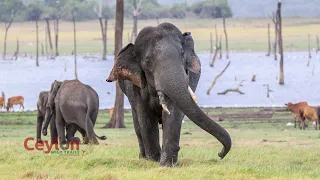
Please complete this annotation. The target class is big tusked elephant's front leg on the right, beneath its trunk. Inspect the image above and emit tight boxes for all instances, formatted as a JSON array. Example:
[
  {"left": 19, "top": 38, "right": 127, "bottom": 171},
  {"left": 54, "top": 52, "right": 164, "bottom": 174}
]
[{"left": 159, "top": 93, "right": 184, "bottom": 167}]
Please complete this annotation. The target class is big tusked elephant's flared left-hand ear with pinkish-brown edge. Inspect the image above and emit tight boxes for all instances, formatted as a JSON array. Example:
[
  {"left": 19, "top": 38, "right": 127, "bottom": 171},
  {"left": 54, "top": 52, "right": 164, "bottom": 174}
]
[{"left": 107, "top": 43, "right": 146, "bottom": 88}]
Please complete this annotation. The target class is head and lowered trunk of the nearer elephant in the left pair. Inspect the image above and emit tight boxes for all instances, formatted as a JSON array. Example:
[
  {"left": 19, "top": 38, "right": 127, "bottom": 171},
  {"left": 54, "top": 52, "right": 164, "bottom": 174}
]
[{"left": 42, "top": 80, "right": 62, "bottom": 136}]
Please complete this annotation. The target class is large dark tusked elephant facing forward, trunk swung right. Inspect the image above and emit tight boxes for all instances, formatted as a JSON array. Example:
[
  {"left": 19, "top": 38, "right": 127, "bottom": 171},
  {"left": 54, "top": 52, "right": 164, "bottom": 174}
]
[{"left": 107, "top": 23, "right": 231, "bottom": 166}]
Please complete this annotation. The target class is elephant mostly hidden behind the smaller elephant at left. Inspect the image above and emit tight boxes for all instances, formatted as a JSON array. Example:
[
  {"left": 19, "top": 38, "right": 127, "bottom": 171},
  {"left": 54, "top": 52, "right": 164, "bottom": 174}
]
[{"left": 37, "top": 91, "right": 85, "bottom": 144}]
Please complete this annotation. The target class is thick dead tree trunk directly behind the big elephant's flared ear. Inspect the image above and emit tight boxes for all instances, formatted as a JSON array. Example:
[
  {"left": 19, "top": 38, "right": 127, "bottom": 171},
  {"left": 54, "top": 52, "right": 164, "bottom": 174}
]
[{"left": 105, "top": 0, "right": 125, "bottom": 128}]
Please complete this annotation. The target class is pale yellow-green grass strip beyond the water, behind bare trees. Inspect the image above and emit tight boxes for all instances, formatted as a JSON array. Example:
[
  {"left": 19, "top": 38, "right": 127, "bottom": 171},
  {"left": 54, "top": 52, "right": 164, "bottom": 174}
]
[{"left": 0, "top": 18, "right": 320, "bottom": 56}]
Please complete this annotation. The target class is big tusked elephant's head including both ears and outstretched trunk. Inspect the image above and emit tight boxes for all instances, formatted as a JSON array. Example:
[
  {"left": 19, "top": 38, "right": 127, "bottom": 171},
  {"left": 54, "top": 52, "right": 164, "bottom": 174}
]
[{"left": 107, "top": 23, "right": 231, "bottom": 158}]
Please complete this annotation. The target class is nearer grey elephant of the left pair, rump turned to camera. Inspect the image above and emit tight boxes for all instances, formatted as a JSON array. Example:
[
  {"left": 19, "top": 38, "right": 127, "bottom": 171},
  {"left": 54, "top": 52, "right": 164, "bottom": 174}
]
[{"left": 42, "top": 80, "right": 106, "bottom": 144}]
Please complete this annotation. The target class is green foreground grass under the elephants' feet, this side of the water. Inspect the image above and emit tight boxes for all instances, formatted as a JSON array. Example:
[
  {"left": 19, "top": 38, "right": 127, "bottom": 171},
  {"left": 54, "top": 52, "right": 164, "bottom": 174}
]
[{"left": 0, "top": 108, "right": 320, "bottom": 180}]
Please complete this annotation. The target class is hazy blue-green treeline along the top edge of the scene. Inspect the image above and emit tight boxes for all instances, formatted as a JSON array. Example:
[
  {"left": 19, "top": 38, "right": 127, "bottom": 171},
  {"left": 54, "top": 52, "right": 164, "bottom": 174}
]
[{"left": 0, "top": 0, "right": 232, "bottom": 22}]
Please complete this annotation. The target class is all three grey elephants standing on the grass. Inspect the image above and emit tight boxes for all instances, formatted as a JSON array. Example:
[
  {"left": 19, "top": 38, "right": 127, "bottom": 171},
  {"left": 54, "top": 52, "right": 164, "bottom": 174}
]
[{"left": 37, "top": 23, "right": 232, "bottom": 166}]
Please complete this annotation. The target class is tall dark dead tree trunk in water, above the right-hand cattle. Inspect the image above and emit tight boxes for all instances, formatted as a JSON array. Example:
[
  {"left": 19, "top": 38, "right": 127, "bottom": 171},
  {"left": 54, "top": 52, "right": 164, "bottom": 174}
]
[{"left": 277, "top": 1, "right": 284, "bottom": 85}]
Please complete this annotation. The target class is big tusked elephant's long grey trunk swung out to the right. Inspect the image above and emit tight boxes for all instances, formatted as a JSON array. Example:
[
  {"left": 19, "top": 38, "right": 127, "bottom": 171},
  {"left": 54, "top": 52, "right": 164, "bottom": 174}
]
[{"left": 155, "top": 65, "right": 232, "bottom": 159}]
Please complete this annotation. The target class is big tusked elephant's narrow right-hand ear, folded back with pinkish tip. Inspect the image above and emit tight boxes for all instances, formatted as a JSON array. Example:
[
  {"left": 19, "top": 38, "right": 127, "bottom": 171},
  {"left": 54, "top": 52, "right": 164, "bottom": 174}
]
[{"left": 182, "top": 32, "right": 201, "bottom": 74}]
